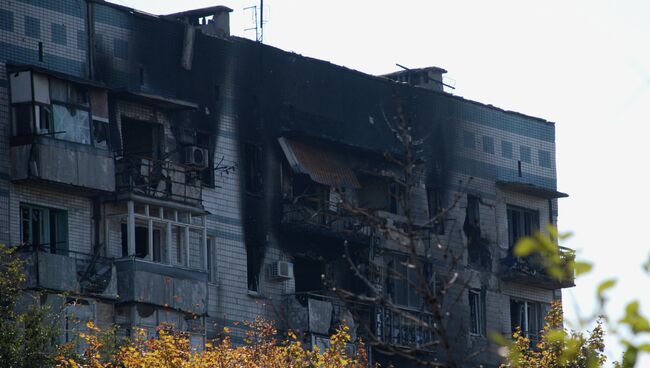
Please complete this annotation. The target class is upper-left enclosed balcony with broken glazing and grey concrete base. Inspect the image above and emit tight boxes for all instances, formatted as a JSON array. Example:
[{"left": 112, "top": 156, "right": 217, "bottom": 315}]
[{"left": 10, "top": 67, "right": 115, "bottom": 192}]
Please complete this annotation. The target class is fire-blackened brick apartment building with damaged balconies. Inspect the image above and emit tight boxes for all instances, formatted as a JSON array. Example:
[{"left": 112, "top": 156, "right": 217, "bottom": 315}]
[{"left": 0, "top": 0, "right": 573, "bottom": 367}]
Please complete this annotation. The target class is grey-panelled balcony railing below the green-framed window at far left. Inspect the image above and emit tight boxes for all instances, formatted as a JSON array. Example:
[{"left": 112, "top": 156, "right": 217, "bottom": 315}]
[{"left": 20, "top": 244, "right": 117, "bottom": 298}]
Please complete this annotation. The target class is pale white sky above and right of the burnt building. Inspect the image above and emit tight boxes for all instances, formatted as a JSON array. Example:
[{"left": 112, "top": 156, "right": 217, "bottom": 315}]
[{"left": 112, "top": 0, "right": 650, "bottom": 367}]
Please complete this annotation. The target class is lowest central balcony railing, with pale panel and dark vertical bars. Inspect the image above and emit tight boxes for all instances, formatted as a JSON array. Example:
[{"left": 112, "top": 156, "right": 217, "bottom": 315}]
[{"left": 286, "top": 292, "right": 434, "bottom": 351}]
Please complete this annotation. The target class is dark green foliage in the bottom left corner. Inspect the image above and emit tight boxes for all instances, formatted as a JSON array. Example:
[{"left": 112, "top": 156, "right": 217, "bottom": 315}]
[{"left": 0, "top": 245, "right": 58, "bottom": 368}]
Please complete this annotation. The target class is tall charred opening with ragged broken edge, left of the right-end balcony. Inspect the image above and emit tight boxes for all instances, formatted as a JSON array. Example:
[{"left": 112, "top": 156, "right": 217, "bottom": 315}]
[{"left": 463, "top": 194, "right": 492, "bottom": 270}]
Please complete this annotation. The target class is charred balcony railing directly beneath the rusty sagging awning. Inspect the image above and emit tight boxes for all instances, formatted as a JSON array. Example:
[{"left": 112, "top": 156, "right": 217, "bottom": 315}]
[{"left": 282, "top": 197, "right": 374, "bottom": 243}]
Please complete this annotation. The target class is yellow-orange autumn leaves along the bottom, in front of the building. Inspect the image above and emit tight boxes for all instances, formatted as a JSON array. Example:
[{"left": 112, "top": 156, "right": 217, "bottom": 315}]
[{"left": 57, "top": 319, "right": 367, "bottom": 368}]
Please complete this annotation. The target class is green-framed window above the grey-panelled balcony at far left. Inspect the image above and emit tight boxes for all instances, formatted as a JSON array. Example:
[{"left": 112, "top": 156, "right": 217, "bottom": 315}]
[{"left": 20, "top": 204, "right": 68, "bottom": 255}]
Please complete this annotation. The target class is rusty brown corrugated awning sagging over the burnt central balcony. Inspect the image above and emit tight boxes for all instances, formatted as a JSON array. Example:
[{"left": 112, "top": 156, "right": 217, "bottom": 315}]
[{"left": 278, "top": 137, "right": 361, "bottom": 188}]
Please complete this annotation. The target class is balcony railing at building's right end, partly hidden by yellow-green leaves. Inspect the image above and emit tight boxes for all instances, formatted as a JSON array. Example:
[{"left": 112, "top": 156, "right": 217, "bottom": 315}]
[{"left": 499, "top": 247, "right": 575, "bottom": 289}]
